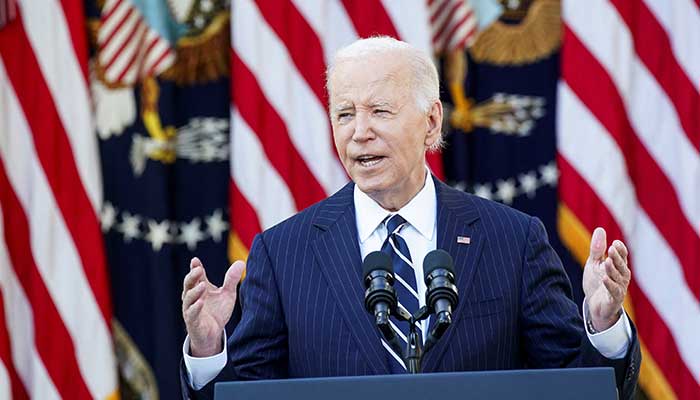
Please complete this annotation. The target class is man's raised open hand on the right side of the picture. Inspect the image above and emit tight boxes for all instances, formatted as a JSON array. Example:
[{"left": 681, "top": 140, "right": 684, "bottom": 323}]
[{"left": 583, "top": 228, "right": 631, "bottom": 332}]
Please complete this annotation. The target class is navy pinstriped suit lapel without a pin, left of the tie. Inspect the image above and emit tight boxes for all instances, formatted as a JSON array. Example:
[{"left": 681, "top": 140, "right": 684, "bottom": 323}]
[{"left": 313, "top": 183, "right": 390, "bottom": 374}]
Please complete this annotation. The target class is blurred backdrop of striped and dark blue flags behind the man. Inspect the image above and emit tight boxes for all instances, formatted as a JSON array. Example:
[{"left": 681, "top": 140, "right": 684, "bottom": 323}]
[{"left": 0, "top": 0, "right": 700, "bottom": 400}]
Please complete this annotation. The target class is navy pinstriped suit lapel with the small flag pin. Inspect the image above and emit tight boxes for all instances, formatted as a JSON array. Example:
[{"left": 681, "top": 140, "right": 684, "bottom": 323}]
[{"left": 423, "top": 179, "right": 483, "bottom": 372}]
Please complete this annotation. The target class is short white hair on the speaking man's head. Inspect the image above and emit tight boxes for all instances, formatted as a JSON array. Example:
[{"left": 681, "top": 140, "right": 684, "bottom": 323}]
[{"left": 326, "top": 36, "right": 444, "bottom": 150}]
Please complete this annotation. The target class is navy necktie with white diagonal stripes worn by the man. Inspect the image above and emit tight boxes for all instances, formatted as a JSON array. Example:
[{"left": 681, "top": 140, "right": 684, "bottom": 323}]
[{"left": 382, "top": 214, "right": 420, "bottom": 373}]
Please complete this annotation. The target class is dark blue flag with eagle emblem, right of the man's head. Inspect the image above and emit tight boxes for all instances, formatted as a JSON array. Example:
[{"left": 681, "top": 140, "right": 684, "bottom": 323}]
[{"left": 440, "top": 0, "right": 583, "bottom": 300}]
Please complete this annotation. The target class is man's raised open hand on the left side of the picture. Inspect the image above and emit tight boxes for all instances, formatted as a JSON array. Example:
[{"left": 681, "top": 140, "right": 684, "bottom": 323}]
[{"left": 182, "top": 257, "right": 245, "bottom": 357}]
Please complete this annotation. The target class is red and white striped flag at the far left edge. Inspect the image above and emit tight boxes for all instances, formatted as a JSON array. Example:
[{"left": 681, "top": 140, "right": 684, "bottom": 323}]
[{"left": 0, "top": 0, "right": 117, "bottom": 399}]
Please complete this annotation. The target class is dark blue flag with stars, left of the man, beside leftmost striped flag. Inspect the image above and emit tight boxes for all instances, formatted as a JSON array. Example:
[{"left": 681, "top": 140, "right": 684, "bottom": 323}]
[{"left": 86, "top": 0, "right": 230, "bottom": 399}]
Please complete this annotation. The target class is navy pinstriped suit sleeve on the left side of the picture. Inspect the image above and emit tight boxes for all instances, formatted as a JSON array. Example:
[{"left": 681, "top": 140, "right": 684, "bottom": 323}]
[{"left": 180, "top": 235, "right": 288, "bottom": 399}]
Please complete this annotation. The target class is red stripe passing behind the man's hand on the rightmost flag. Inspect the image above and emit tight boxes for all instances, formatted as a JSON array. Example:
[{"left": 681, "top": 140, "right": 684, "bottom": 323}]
[{"left": 557, "top": 154, "right": 700, "bottom": 399}]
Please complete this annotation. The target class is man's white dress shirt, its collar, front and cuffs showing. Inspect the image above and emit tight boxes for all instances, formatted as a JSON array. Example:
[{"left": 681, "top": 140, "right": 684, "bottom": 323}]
[{"left": 182, "top": 172, "right": 632, "bottom": 390}]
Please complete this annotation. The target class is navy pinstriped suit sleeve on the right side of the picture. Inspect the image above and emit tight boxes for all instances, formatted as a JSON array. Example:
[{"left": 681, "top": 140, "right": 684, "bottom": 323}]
[{"left": 520, "top": 218, "right": 641, "bottom": 399}]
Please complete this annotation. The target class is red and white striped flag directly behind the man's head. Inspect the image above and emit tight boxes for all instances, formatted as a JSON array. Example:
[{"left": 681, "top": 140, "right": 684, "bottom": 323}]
[{"left": 231, "top": 0, "right": 442, "bottom": 258}]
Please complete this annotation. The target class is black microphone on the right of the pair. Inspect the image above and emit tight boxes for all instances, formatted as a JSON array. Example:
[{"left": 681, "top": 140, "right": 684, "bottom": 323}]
[{"left": 423, "top": 249, "right": 459, "bottom": 340}]
